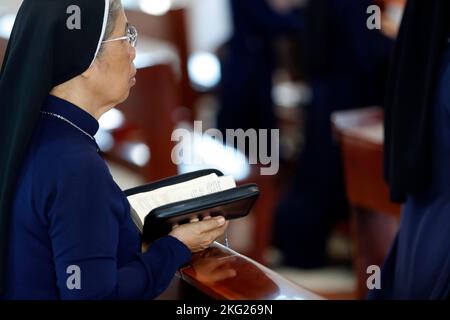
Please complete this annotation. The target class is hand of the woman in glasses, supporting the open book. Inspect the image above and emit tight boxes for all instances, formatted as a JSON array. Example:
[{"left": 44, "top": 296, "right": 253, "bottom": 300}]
[{"left": 169, "top": 216, "right": 228, "bottom": 252}]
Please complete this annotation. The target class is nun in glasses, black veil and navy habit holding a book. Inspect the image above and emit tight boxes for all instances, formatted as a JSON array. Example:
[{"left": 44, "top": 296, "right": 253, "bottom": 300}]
[{"left": 0, "top": 0, "right": 227, "bottom": 299}]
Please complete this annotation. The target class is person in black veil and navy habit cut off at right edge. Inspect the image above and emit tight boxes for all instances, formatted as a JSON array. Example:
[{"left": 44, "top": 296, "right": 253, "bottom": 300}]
[{"left": 369, "top": 0, "right": 450, "bottom": 299}]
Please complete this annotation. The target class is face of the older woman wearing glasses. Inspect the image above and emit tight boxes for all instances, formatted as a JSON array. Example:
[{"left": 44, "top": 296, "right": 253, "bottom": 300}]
[{"left": 93, "top": 10, "right": 136, "bottom": 105}]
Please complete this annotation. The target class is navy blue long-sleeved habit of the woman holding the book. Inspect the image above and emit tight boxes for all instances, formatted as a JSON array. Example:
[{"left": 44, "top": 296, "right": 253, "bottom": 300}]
[{"left": 2, "top": 96, "right": 191, "bottom": 299}]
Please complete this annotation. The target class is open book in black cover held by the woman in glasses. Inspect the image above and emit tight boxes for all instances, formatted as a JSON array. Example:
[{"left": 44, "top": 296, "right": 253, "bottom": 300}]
[{"left": 125, "top": 170, "right": 259, "bottom": 240}]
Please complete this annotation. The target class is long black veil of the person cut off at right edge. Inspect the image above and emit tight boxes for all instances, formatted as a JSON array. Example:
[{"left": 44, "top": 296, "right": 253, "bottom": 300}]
[{"left": 384, "top": 0, "right": 450, "bottom": 202}]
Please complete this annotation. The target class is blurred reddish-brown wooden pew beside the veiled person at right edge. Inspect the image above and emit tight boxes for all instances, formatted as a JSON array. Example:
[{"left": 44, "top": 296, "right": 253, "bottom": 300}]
[{"left": 332, "top": 107, "right": 401, "bottom": 298}]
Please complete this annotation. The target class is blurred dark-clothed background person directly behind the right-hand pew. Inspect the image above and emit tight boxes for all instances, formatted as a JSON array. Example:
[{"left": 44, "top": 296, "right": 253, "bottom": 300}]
[{"left": 275, "top": 0, "right": 404, "bottom": 268}]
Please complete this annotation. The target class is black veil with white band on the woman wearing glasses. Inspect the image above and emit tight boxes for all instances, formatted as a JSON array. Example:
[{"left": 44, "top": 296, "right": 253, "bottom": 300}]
[{"left": 0, "top": 0, "right": 109, "bottom": 293}]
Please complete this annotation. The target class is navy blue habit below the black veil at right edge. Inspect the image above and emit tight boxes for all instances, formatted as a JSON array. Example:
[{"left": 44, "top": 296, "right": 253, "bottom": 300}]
[{"left": 369, "top": 49, "right": 450, "bottom": 299}]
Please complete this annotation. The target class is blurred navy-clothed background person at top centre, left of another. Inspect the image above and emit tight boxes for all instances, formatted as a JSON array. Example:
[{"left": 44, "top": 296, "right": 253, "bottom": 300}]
[{"left": 217, "top": 0, "right": 299, "bottom": 133}]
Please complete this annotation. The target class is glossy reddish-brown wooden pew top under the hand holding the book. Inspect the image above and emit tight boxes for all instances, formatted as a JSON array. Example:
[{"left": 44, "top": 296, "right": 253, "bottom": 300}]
[{"left": 159, "top": 242, "right": 323, "bottom": 301}]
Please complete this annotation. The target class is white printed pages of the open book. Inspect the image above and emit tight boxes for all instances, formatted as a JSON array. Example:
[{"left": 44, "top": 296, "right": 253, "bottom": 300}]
[{"left": 128, "top": 173, "right": 236, "bottom": 224}]
